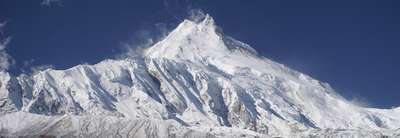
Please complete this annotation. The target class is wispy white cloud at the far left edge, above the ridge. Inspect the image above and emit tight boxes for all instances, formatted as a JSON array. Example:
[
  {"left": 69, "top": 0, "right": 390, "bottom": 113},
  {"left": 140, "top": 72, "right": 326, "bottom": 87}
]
[{"left": 0, "top": 22, "right": 15, "bottom": 70}]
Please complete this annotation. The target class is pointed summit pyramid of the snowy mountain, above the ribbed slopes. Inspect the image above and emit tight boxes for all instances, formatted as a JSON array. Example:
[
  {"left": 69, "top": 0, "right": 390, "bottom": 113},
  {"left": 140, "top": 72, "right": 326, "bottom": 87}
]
[{"left": 145, "top": 14, "right": 229, "bottom": 61}]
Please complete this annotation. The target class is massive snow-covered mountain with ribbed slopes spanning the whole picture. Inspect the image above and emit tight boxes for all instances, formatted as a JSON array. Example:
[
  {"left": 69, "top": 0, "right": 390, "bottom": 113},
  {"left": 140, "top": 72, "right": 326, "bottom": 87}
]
[{"left": 0, "top": 15, "right": 400, "bottom": 137}]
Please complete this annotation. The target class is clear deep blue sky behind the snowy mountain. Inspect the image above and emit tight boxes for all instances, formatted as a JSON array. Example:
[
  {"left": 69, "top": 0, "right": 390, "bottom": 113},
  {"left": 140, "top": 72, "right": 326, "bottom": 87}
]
[{"left": 0, "top": 0, "right": 400, "bottom": 108}]
